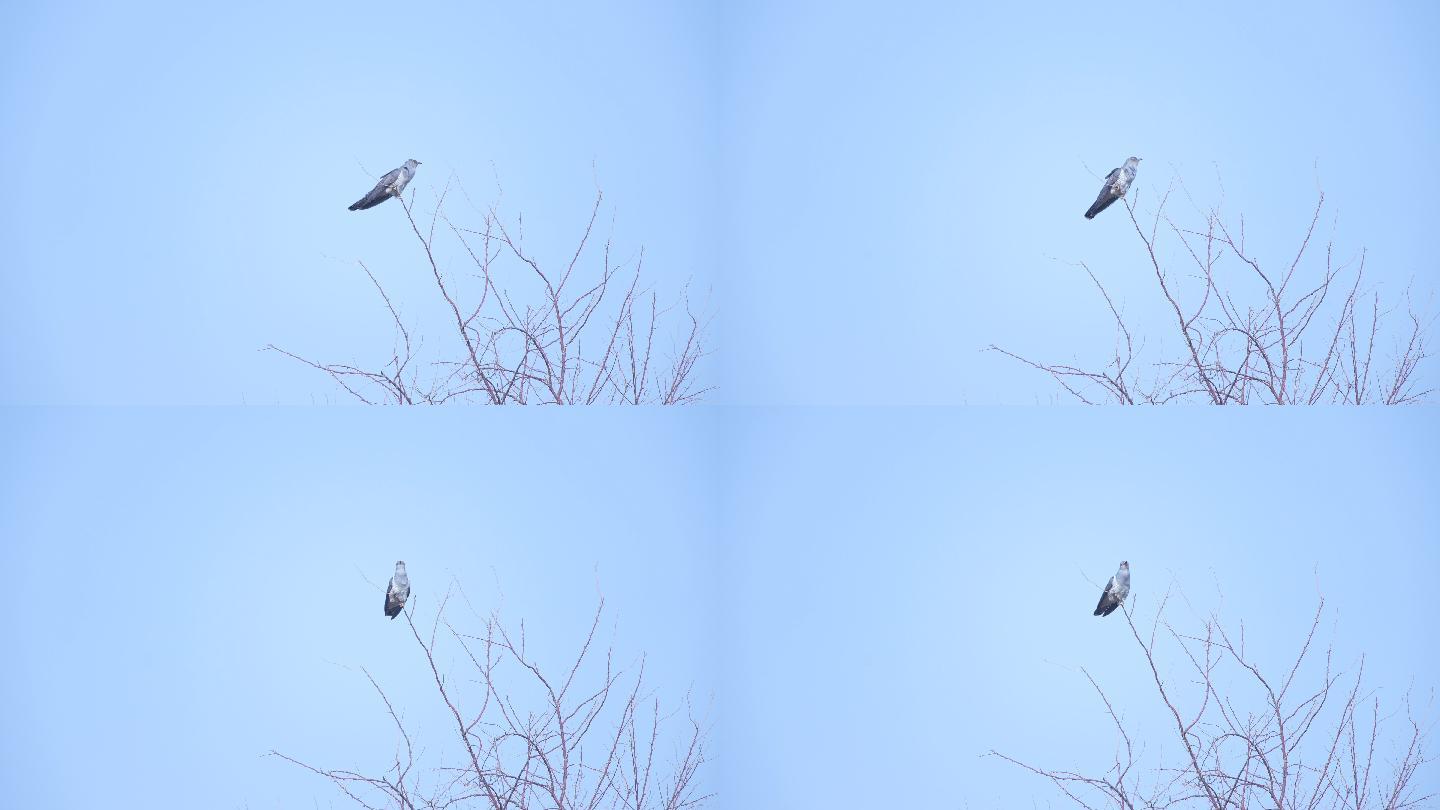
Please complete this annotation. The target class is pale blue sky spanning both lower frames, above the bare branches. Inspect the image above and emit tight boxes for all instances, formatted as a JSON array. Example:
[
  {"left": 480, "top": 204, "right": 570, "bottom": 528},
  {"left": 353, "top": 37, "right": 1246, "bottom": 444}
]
[{"left": 0, "top": 408, "right": 1440, "bottom": 809}]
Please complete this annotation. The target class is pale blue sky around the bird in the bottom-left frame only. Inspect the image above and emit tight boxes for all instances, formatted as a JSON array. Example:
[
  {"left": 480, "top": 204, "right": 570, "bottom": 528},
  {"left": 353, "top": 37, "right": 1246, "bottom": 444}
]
[{"left": 0, "top": 409, "right": 719, "bottom": 809}]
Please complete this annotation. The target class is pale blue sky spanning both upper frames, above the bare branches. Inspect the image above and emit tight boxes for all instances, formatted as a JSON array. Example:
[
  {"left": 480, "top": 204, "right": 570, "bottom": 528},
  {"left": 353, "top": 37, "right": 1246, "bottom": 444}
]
[{"left": 0, "top": 0, "right": 1440, "bottom": 404}]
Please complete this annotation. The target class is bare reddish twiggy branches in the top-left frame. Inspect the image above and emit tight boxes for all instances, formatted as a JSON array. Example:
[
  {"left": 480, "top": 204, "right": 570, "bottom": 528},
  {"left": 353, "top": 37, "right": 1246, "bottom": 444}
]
[{"left": 266, "top": 179, "right": 710, "bottom": 405}]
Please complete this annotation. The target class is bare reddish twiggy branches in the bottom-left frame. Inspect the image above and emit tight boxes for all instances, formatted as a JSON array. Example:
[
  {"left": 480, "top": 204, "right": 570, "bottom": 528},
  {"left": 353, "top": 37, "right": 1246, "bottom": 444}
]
[{"left": 271, "top": 585, "right": 710, "bottom": 810}]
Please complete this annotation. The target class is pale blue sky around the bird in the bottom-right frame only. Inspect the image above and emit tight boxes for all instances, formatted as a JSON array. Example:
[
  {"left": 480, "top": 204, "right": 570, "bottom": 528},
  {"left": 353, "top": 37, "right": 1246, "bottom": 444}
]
[{"left": 720, "top": 408, "right": 1440, "bottom": 809}]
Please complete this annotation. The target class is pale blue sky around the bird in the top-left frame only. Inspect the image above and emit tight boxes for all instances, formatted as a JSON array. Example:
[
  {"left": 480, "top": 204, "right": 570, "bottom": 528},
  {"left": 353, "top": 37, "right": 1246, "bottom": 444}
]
[{"left": 0, "top": 0, "right": 720, "bottom": 405}]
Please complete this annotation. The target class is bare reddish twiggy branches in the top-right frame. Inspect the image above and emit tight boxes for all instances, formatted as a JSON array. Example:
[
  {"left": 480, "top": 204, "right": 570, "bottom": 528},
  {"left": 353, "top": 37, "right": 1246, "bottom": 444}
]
[{"left": 989, "top": 180, "right": 1431, "bottom": 405}]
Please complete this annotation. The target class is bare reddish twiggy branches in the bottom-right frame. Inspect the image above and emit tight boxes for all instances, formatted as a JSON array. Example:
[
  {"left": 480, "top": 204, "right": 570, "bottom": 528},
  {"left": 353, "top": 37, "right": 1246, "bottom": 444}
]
[{"left": 989, "top": 585, "right": 1436, "bottom": 810}]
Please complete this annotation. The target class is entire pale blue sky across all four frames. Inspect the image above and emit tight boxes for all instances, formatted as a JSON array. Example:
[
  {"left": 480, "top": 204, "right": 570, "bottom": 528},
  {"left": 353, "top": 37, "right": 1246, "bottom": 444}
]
[{"left": 0, "top": 0, "right": 1440, "bottom": 810}]
